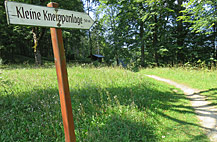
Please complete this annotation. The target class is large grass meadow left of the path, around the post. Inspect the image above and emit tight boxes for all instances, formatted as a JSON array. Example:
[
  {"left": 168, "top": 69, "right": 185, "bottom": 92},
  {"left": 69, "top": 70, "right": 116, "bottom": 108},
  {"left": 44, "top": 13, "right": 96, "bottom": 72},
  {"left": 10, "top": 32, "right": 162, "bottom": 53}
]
[{"left": 0, "top": 65, "right": 209, "bottom": 142}]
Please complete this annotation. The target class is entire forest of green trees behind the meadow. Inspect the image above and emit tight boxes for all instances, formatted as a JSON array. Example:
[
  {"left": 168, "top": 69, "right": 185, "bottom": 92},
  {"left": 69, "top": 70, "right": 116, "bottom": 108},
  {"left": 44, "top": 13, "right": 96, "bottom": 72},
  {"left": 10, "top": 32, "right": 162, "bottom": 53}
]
[{"left": 0, "top": 0, "right": 217, "bottom": 68}]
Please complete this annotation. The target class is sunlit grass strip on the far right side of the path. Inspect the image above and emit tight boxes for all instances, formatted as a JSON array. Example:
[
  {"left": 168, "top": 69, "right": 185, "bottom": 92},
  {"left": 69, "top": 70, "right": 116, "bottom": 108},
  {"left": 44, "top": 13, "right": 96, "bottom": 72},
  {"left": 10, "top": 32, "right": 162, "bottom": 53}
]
[{"left": 140, "top": 68, "right": 217, "bottom": 105}]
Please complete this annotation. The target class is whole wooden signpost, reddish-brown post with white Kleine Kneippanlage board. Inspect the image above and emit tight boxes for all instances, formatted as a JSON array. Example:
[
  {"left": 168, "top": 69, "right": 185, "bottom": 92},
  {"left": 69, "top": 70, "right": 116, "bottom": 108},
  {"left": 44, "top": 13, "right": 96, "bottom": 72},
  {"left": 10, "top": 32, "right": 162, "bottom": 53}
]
[{"left": 5, "top": 1, "right": 94, "bottom": 142}]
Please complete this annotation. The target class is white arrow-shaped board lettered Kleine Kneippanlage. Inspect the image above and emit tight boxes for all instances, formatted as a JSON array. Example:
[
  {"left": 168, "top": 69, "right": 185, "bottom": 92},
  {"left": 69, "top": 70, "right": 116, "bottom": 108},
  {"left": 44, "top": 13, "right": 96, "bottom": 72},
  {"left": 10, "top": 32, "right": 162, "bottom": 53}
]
[{"left": 5, "top": 1, "right": 94, "bottom": 29}]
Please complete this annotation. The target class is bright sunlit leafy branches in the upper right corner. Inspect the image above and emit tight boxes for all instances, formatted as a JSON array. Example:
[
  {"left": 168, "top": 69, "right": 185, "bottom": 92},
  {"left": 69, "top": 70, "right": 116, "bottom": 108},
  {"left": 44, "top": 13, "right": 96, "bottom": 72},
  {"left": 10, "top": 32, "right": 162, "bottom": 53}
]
[{"left": 178, "top": 0, "right": 217, "bottom": 33}]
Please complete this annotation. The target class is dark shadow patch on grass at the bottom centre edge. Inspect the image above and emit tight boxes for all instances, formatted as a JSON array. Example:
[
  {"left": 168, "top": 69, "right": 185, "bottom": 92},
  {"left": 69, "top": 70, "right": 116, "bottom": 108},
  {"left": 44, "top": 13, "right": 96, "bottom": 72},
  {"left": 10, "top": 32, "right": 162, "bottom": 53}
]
[{"left": 86, "top": 114, "right": 158, "bottom": 142}]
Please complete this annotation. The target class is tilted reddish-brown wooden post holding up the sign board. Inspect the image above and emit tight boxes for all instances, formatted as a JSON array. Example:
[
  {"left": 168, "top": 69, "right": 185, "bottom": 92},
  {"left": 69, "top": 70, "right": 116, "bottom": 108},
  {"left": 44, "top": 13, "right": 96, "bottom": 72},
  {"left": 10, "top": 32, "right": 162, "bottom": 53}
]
[{"left": 47, "top": 2, "right": 76, "bottom": 142}]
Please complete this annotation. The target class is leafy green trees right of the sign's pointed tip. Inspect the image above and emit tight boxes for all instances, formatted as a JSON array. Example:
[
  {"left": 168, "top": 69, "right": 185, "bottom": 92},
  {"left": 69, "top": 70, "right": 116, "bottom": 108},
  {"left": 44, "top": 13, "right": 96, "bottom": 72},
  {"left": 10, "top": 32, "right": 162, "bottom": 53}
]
[{"left": 97, "top": 0, "right": 217, "bottom": 66}]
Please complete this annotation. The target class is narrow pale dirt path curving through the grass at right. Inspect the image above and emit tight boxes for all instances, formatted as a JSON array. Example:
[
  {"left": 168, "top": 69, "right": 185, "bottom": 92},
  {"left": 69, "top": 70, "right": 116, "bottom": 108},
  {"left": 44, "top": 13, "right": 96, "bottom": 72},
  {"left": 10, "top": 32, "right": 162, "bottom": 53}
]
[{"left": 146, "top": 75, "right": 217, "bottom": 142}]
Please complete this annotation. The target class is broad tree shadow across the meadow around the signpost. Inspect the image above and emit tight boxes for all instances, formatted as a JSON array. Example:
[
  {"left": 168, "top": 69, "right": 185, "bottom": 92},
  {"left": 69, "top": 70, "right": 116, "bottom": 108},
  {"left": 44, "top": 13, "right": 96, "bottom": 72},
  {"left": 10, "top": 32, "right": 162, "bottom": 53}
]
[{"left": 0, "top": 79, "right": 209, "bottom": 142}]
